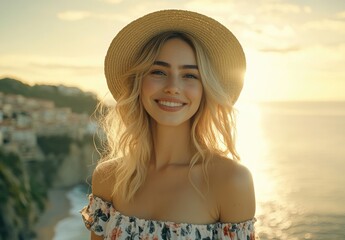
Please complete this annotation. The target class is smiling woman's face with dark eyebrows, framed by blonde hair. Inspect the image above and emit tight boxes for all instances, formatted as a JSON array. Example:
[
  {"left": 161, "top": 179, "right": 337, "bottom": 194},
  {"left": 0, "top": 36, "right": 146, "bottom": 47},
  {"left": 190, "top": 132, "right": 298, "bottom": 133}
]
[{"left": 141, "top": 38, "right": 203, "bottom": 126}]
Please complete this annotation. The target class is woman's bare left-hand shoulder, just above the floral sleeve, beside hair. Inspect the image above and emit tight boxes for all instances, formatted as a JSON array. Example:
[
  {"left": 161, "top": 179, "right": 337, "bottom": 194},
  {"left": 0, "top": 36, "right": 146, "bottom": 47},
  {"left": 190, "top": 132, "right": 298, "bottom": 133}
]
[{"left": 92, "top": 160, "right": 117, "bottom": 202}]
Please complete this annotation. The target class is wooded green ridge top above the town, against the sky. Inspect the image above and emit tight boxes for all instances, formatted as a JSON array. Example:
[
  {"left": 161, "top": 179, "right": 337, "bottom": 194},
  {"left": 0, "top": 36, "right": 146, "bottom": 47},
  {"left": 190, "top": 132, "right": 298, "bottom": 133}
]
[{"left": 0, "top": 78, "right": 98, "bottom": 115}]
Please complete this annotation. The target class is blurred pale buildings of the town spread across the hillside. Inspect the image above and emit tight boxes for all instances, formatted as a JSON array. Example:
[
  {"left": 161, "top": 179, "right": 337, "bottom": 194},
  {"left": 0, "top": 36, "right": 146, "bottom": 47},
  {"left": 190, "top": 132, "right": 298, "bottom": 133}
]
[{"left": 0, "top": 92, "right": 96, "bottom": 160}]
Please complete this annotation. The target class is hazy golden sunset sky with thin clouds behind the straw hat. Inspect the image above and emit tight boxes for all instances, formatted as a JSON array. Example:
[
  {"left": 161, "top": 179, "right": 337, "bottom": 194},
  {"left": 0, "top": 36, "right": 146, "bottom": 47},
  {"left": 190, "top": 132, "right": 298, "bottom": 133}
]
[{"left": 0, "top": 0, "right": 345, "bottom": 101}]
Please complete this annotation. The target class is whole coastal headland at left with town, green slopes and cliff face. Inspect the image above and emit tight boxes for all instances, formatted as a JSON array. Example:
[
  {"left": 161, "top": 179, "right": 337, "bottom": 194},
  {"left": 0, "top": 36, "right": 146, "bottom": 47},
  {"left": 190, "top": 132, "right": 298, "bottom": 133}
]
[{"left": 0, "top": 78, "right": 99, "bottom": 240}]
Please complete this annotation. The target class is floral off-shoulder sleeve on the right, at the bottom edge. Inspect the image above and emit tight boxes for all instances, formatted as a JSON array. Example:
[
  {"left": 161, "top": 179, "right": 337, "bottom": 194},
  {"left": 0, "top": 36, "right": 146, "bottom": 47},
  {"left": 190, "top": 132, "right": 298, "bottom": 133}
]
[{"left": 218, "top": 218, "right": 258, "bottom": 240}]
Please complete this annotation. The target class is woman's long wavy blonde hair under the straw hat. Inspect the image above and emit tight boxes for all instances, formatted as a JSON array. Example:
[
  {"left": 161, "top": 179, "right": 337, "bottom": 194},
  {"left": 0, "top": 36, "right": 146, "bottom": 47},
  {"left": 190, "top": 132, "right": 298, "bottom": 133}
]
[{"left": 95, "top": 32, "right": 239, "bottom": 201}]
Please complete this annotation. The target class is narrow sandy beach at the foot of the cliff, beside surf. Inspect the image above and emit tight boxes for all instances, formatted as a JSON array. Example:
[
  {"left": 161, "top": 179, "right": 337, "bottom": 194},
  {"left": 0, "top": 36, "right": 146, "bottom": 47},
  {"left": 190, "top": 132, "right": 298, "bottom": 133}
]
[{"left": 34, "top": 188, "right": 71, "bottom": 240}]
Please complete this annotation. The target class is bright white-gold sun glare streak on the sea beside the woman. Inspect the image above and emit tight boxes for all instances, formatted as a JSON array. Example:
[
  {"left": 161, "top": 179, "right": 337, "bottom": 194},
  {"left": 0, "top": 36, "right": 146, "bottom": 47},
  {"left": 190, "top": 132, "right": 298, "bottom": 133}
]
[{"left": 236, "top": 101, "right": 289, "bottom": 237}]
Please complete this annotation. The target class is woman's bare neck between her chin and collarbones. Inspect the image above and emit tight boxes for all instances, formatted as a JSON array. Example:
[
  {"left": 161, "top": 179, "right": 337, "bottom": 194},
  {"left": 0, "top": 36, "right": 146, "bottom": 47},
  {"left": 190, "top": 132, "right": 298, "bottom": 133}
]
[{"left": 152, "top": 122, "right": 193, "bottom": 170}]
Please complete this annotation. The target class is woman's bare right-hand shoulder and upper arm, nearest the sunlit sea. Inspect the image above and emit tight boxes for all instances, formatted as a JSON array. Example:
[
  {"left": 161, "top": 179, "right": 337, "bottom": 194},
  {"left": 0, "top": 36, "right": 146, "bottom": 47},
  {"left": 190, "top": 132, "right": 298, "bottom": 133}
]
[{"left": 210, "top": 157, "right": 255, "bottom": 223}]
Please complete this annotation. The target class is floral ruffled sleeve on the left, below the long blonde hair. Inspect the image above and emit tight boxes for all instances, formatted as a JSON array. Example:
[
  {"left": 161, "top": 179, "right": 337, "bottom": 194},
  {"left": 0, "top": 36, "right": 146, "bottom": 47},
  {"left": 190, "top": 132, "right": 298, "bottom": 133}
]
[{"left": 80, "top": 194, "right": 111, "bottom": 236}]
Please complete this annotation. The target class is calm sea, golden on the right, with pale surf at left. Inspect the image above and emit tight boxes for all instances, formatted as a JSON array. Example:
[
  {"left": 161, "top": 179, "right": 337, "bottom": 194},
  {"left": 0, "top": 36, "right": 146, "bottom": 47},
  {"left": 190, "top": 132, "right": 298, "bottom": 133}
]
[{"left": 54, "top": 102, "right": 345, "bottom": 240}]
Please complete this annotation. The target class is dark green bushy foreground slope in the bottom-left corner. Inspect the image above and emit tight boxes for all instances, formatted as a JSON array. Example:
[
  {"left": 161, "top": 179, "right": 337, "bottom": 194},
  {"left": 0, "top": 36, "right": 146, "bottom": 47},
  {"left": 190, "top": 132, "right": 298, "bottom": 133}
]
[{"left": 0, "top": 151, "right": 39, "bottom": 239}]
